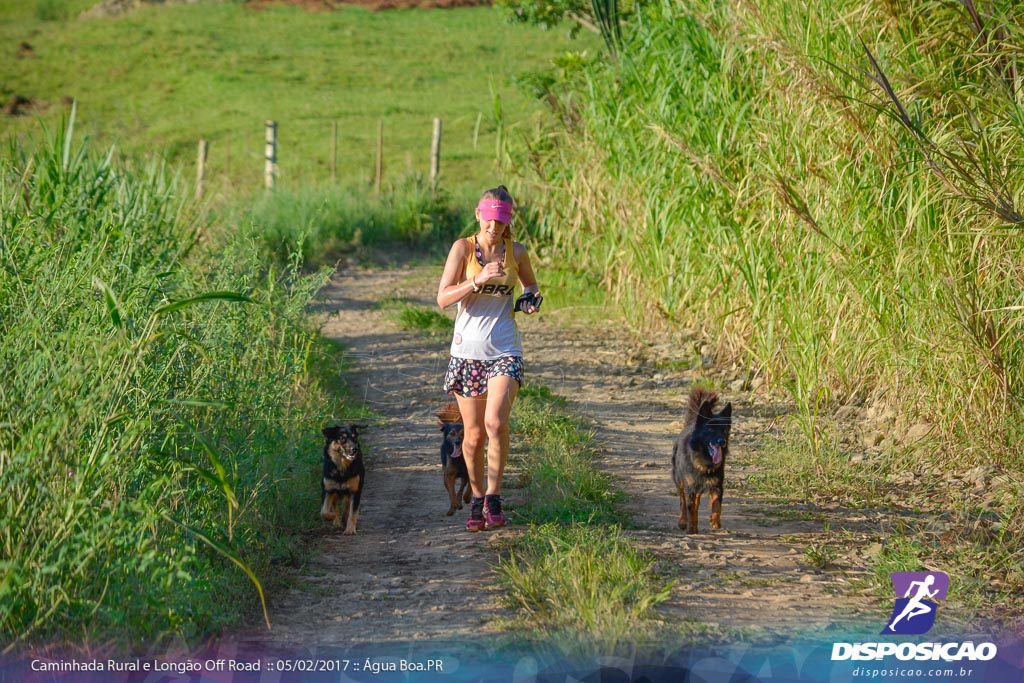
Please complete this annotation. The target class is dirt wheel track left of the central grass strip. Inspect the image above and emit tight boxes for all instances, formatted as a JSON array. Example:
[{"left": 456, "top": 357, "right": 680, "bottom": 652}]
[{"left": 246, "top": 268, "right": 516, "bottom": 647}]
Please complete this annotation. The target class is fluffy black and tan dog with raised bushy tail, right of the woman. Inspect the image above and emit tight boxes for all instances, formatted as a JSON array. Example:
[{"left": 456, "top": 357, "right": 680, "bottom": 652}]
[{"left": 672, "top": 388, "right": 732, "bottom": 533}]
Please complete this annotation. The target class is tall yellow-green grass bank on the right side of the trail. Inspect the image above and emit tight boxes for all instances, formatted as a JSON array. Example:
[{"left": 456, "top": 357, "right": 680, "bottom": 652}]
[{"left": 512, "top": 0, "right": 1024, "bottom": 610}]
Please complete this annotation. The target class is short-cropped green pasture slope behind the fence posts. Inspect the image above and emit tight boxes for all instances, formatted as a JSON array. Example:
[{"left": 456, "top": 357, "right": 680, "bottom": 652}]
[{"left": 0, "top": 0, "right": 592, "bottom": 202}]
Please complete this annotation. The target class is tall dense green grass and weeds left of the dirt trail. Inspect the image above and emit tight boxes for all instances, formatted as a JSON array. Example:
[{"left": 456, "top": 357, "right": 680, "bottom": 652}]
[{"left": 0, "top": 115, "right": 339, "bottom": 648}]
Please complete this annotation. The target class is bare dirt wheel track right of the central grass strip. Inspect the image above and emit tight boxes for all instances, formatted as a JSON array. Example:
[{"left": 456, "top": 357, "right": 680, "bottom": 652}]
[{"left": 521, "top": 311, "right": 881, "bottom": 639}]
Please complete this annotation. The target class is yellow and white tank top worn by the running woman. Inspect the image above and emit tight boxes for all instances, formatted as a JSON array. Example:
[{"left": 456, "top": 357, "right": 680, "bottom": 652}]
[{"left": 452, "top": 236, "right": 522, "bottom": 360}]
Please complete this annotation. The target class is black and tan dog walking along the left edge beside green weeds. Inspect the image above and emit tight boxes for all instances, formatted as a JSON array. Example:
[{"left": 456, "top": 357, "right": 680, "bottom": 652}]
[{"left": 321, "top": 425, "right": 367, "bottom": 536}]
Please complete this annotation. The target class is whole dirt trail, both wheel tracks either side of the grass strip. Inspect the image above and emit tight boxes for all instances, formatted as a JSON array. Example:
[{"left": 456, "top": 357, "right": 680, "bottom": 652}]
[{"left": 235, "top": 260, "right": 879, "bottom": 648}]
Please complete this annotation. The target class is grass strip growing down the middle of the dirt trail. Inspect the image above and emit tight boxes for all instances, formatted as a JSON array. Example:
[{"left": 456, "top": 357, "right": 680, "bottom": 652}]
[{"left": 499, "top": 384, "right": 671, "bottom": 654}]
